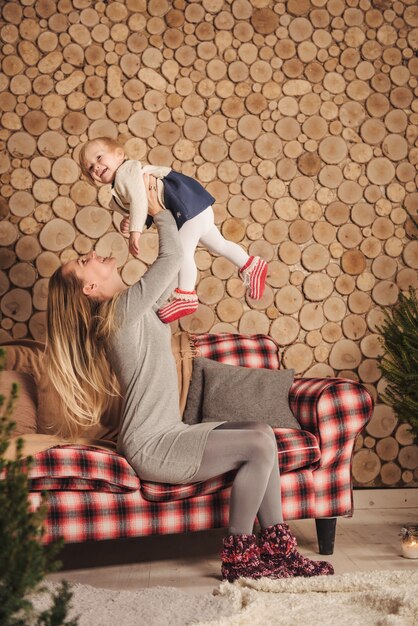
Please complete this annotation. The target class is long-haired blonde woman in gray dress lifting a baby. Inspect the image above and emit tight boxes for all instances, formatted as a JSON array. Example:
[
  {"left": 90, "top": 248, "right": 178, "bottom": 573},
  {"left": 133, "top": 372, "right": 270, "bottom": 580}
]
[{"left": 47, "top": 177, "right": 333, "bottom": 581}]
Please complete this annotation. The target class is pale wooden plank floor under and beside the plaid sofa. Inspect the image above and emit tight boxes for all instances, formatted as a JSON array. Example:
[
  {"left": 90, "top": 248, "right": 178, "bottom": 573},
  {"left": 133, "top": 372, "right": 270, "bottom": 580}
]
[{"left": 49, "top": 489, "right": 418, "bottom": 593}]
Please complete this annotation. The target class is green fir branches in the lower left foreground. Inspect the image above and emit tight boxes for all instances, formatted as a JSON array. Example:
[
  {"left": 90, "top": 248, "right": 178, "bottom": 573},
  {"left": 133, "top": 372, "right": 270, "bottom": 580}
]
[{"left": 0, "top": 348, "right": 78, "bottom": 626}]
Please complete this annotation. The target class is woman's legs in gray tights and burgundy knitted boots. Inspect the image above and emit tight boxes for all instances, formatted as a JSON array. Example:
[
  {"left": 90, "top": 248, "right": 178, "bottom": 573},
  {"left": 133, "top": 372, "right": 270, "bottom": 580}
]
[{"left": 193, "top": 422, "right": 334, "bottom": 581}]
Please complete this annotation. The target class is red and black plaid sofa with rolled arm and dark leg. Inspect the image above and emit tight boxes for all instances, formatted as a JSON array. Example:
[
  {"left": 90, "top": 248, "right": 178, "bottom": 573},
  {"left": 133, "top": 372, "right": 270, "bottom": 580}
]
[{"left": 29, "top": 333, "right": 372, "bottom": 554}]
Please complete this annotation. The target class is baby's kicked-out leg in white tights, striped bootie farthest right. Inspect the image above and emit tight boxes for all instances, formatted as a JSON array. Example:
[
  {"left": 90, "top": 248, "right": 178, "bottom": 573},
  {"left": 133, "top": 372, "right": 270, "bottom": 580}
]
[{"left": 200, "top": 208, "right": 267, "bottom": 300}]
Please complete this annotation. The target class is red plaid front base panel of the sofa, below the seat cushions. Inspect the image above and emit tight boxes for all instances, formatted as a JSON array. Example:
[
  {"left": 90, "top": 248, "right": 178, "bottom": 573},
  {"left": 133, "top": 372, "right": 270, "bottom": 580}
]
[{"left": 31, "top": 470, "right": 316, "bottom": 543}]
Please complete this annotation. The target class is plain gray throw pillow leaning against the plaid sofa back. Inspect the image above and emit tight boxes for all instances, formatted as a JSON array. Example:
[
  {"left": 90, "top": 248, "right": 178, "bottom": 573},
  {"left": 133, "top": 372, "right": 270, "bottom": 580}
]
[{"left": 183, "top": 357, "right": 300, "bottom": 430}]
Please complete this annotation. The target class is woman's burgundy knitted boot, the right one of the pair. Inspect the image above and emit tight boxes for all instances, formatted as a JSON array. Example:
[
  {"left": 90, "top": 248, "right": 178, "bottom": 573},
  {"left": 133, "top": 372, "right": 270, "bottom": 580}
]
[{"left": 259, "top": 524, "right": 334, "bottom": 576}]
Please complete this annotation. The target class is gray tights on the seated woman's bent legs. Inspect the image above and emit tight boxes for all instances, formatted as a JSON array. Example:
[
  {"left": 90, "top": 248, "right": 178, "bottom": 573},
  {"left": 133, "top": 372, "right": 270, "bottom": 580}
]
[{"left": 193, "top": 422, "right": 283, "bottom": 535}]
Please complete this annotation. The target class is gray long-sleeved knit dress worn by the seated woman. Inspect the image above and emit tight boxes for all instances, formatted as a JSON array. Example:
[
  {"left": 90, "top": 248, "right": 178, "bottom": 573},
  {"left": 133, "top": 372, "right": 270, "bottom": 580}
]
[{"left": 109, "top": 211, "right": 222, "bottom": 483}]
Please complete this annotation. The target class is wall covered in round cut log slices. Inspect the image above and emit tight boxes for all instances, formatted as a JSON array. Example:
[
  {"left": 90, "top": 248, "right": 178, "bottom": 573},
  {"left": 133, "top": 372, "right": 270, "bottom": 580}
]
[{"left": 0, "top": 0, "right": 418, "bottom": 486}]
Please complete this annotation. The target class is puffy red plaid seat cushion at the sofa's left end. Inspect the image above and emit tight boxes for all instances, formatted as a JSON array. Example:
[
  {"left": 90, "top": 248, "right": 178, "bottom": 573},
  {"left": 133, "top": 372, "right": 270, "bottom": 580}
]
[{"left": 28, "top": 444, "right": 139, "bottom": 493}]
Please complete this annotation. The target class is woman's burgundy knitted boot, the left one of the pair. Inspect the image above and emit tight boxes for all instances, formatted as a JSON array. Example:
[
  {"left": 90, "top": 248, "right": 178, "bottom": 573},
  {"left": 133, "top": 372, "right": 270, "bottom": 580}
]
[{"left": 221, "top": 535, "right": 291, "bottom": 582}]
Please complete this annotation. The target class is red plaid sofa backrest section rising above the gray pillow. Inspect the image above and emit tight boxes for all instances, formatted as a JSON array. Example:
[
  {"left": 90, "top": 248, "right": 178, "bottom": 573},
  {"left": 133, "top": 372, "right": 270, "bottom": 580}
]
[{"left": 190, "top": 333, "right": 280, "bottom": 369}]
